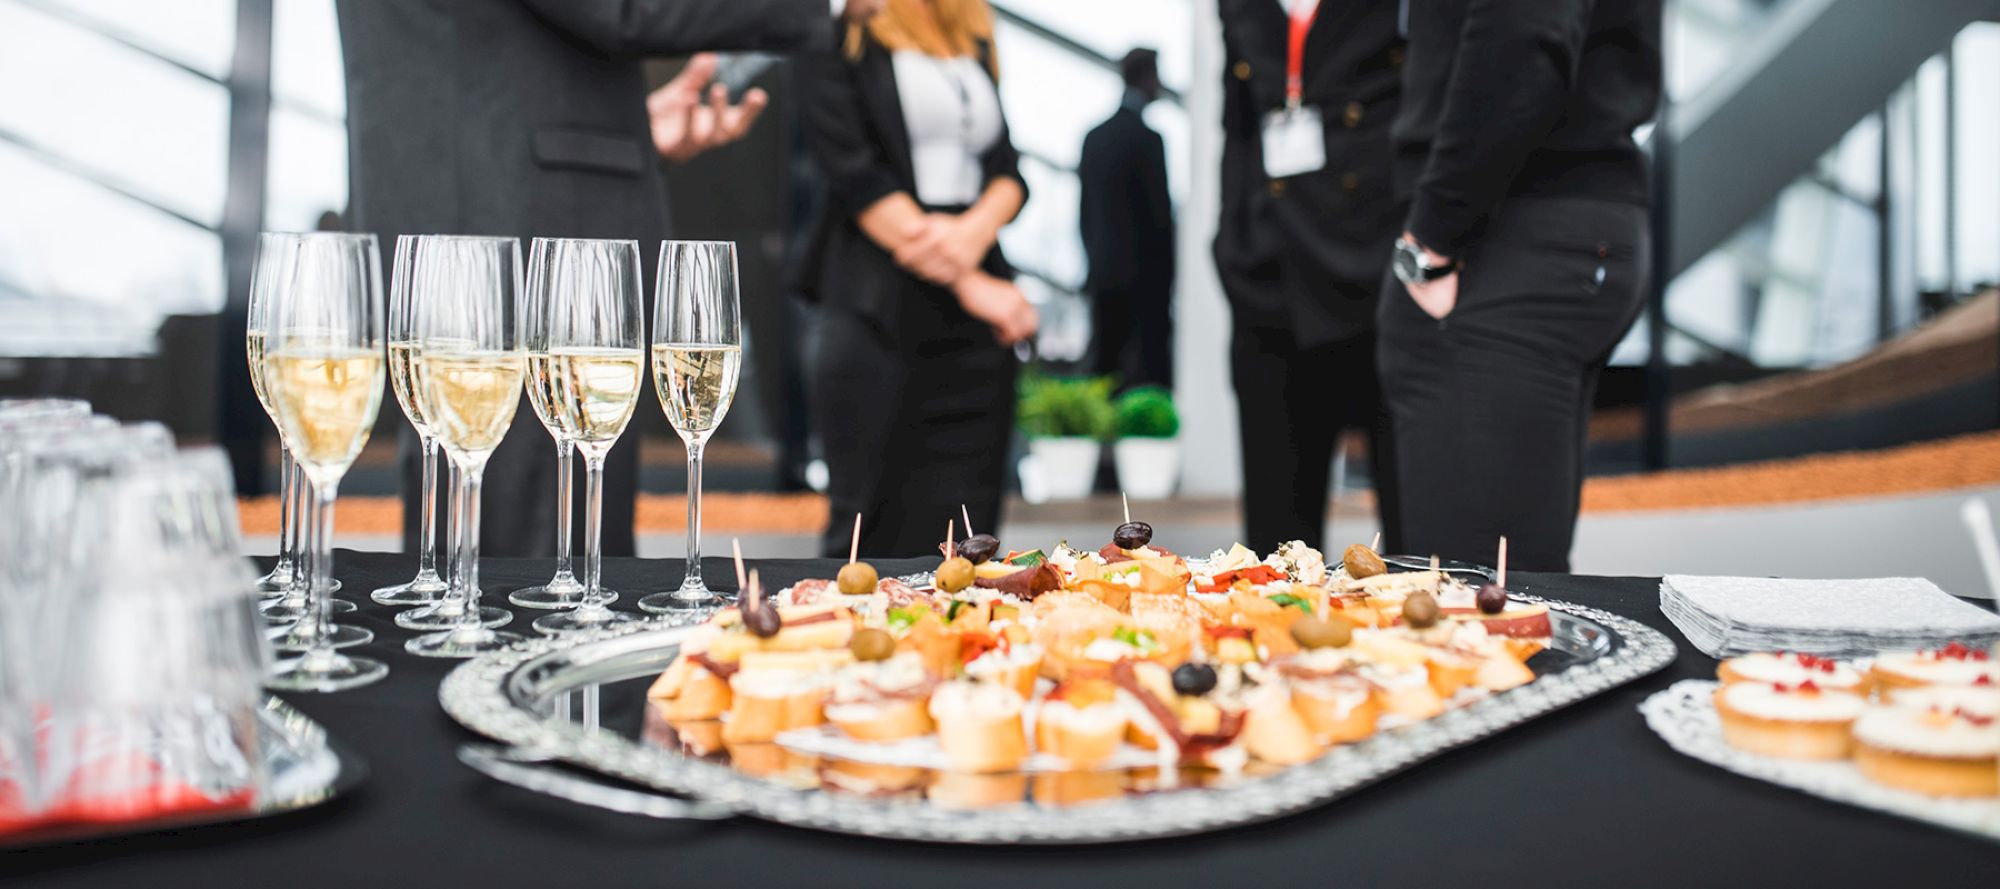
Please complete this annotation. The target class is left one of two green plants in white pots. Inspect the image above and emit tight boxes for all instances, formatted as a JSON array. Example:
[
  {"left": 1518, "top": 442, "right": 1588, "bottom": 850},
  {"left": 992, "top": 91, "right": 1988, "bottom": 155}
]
[{"left": 1016, "top": 372, "right": 1112, "bottom": 501}]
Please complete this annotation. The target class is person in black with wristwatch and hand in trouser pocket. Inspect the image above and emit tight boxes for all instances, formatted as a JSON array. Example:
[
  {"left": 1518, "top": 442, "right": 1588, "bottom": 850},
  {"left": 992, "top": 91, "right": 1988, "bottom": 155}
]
[{"left": 1380, "top": 0, "right": 1660, "bottom": 571}]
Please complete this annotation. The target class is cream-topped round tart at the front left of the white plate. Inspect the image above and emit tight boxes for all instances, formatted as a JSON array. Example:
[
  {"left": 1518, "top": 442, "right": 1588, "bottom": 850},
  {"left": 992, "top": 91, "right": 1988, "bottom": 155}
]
[{"left": 1716, "top": 681, "right": 1868, "bottom": 759}]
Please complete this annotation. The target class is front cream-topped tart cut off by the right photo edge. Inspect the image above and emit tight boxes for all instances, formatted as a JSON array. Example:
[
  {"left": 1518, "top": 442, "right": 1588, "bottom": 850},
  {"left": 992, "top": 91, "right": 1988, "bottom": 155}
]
[{"left": 1854, "top": 687, "right": 2000, "bottom": 797}]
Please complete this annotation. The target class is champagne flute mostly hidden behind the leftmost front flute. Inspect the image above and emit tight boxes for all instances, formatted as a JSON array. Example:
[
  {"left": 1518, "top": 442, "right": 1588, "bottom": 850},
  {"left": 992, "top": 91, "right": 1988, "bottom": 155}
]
[{"left": 244, "top": 232, "right": 354, "bottom": 624}]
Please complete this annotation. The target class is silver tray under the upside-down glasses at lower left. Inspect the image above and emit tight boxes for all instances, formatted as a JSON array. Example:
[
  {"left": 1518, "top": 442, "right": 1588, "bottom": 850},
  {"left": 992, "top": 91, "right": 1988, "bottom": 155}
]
[{"left": 0, "top": 697, "right": 368, "bottom": 849}]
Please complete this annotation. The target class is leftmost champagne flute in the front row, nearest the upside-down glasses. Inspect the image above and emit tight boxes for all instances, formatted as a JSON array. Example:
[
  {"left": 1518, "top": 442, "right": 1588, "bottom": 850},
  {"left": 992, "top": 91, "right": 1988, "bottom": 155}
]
[{"left": 262, "top": 232, "right": 388, "bottom": 691}]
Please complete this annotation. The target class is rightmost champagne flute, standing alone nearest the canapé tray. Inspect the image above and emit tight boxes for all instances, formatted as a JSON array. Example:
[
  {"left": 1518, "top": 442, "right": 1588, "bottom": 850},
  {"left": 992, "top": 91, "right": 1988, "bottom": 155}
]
[{"left": 638, "top": 240, "right": 742, "bottom": 615}]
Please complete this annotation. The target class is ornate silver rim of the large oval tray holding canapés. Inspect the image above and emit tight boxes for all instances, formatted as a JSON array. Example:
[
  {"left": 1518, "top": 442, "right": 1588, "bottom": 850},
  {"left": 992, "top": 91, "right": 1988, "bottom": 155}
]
[{"left": 438, "top": 595, "right": 1674, "bottom": 843}]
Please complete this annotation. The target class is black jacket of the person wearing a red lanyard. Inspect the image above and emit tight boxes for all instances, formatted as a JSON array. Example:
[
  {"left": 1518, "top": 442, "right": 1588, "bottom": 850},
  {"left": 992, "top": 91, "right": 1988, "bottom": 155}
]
[{"left": 1214, "top": 0, "right": 1402, "bottom": 346}]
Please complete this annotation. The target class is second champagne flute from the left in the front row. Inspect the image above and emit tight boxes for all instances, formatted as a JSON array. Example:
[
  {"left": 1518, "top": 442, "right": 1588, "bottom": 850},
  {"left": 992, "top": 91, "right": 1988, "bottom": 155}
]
[{"left": 398, "top": 234, "right": 522, "bottom": 657}]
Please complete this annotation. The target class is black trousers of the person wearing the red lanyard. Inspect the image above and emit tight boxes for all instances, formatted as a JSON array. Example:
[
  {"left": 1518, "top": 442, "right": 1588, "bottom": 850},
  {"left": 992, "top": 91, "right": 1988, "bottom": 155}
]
[{"left": 1230, "top": 318, "right": 1396, "bottom": 555}]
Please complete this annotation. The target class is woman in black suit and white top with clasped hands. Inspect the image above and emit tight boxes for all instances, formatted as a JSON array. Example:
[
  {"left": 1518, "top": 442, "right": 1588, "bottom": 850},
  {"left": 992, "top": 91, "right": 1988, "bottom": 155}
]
[{"left": 798, "top": 0, "right": 1038, "bottom": 557}]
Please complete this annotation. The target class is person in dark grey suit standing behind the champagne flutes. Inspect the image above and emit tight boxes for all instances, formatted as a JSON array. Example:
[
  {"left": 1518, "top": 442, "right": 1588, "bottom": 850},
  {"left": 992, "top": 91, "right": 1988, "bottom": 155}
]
[{"left": 336, "top": 0, "right": 882, "bottom": 557}]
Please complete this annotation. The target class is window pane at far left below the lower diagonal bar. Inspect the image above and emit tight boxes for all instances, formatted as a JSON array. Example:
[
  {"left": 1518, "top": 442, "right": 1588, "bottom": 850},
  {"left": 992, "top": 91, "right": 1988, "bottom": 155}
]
[{"left": 0, "top": 142, "right": 224, "bottom": 354}]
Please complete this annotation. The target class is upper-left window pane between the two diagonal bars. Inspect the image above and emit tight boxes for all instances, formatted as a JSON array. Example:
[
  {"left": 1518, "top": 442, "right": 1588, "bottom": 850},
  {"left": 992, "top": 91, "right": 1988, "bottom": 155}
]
[{"left": 0, "top": 4, "right": 228, "bottom": 226}]
